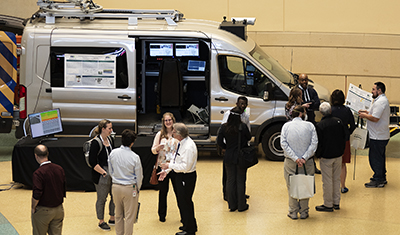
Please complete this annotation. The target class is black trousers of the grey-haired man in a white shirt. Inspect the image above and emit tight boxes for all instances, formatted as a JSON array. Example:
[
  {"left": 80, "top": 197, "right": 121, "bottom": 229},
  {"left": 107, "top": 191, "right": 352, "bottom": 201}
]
[{"left": 174, "top": 171, "right": 197, "bottom": 234}]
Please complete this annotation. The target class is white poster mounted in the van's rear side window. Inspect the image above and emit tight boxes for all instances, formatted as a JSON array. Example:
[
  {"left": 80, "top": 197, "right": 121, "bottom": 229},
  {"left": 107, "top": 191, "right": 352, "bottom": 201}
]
[{"left": 64, "top": 54, "right": 116, "bottom": 88}]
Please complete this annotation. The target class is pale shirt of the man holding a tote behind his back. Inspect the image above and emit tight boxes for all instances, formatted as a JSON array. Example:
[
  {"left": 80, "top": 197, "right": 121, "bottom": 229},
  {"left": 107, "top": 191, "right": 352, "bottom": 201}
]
[{"left": 281, "top": 117, "right": 318, "bottom": 161}]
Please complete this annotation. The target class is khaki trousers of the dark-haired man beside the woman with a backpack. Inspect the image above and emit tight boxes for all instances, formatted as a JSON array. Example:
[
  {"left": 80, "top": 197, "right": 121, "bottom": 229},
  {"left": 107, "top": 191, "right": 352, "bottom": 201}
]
[{"left": 112, "top": 184, "right": 139, "bottom": 235}]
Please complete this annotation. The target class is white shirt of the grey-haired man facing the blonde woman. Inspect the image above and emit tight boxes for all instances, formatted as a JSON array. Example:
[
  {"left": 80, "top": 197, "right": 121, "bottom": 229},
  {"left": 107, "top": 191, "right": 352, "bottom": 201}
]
[{"left": 168, "top": 136, "right": 197, "bottom": 173}]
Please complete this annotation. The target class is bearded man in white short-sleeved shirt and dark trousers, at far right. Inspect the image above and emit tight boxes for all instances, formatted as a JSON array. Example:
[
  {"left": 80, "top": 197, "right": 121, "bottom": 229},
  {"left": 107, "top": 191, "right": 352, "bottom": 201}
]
[{"left": 358, "top": 82, "right": 390, "bottom": 188}]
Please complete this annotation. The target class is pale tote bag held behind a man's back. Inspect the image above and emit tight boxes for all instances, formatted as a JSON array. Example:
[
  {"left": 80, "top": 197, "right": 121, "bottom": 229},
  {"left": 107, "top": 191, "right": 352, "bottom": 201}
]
[{"left": 289, "top": 164, "right": 315, "bottom": 199}]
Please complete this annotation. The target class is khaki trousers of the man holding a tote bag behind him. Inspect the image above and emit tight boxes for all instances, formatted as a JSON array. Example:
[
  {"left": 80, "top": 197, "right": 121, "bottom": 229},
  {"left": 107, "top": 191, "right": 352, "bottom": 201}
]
[{"left": 283, "top": 157, "right": 315, "bottom": 213}]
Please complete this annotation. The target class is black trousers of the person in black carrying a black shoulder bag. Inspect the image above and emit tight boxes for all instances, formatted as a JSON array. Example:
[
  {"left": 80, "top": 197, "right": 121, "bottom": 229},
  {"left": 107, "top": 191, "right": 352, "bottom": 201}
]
[{"left": 225, "top": 163, "right": 247, "bottom": 210}]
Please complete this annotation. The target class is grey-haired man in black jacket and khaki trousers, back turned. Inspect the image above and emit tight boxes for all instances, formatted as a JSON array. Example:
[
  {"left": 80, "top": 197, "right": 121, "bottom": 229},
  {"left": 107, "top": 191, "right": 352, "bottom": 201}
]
[{"left": 315, "top": 102, "right": 346, "bottom": 212}]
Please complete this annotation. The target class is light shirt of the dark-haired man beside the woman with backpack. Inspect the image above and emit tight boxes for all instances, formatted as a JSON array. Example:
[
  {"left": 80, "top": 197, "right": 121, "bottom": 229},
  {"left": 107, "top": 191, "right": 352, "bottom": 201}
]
[{"left": 108, "top": 145, "right": 143, "bottom": 190}]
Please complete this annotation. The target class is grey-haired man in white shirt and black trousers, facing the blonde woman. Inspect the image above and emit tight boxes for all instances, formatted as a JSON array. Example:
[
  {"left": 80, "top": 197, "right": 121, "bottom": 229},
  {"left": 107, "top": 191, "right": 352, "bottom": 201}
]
[{"left": 160, "top": 123, "right": 197, "bottom": 235}]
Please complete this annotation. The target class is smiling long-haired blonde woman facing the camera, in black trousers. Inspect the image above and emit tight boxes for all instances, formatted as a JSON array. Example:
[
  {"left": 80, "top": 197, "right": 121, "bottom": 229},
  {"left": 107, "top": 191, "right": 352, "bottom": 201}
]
[{"left": 151, "top": 112, "right": 178, "bottom": 222}]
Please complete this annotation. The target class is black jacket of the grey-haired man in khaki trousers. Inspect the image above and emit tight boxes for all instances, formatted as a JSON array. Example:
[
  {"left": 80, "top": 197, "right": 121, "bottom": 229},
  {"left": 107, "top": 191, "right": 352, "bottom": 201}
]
[{"left": 316, "top": 115, "right": 346, "bottom": 158}]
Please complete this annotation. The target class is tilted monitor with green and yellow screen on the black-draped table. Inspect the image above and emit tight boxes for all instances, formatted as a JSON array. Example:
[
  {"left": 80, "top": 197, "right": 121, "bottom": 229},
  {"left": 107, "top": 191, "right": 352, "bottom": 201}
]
[{"left": 28, "top": 109, "right": 63, "bottom": 138}]
